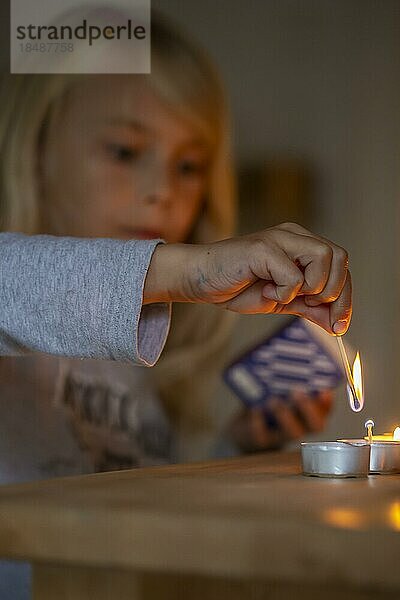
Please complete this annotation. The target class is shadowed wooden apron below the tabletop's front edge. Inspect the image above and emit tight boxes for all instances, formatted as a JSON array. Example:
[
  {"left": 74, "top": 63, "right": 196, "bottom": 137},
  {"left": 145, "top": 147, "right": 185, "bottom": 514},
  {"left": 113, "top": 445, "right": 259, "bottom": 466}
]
[{"left": 33, "top": 565, "right": 390, "bottom": 600}]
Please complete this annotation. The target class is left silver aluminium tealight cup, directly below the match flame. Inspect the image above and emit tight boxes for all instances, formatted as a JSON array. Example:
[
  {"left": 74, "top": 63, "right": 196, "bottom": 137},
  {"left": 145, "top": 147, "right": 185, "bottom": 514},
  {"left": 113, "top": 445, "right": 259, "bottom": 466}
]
[{"left": 301, "top": 440, "right": 371, "bottom": 477}]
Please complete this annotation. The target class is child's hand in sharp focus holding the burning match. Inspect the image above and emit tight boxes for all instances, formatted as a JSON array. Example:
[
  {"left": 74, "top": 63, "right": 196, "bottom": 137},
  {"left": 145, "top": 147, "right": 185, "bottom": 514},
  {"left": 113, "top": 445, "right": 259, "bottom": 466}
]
[{"left": 144, "top": 223, "right": 351, "bottom": 334}]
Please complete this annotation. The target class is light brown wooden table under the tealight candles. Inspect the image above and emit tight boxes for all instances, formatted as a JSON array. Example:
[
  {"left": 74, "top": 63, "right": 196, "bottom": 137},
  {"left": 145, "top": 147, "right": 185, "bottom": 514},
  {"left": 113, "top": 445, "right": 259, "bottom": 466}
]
[{"left": 0, "top": 453, "right": 400, "bottom": 600}]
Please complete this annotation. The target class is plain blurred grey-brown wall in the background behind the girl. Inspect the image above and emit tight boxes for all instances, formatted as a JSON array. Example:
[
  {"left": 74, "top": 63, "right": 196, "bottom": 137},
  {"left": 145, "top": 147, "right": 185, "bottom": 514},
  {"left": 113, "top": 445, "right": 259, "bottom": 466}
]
[{"left": 152, "top": 0, "right": 400, "bottom": 439}]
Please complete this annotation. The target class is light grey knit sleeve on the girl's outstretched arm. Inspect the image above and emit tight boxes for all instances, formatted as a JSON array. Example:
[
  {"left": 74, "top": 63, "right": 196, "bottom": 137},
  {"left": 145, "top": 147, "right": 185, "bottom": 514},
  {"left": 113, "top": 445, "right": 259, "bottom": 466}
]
[{"left": 0, "top": 233, "right": 171, "bottom": 366}]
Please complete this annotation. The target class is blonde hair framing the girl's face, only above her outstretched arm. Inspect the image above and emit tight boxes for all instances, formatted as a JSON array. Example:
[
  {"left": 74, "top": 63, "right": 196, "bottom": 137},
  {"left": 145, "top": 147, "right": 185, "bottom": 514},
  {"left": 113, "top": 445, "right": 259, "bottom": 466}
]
[{"left": 0, "top": 14, "right": 235, "bottom": 241}]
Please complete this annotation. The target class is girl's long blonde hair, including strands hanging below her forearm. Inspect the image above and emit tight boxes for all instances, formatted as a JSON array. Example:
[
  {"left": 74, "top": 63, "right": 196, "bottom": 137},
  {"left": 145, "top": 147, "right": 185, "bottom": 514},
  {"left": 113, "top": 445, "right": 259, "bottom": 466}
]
[{"left": 0, "top": 9, "right": 235, "bottom": 432}]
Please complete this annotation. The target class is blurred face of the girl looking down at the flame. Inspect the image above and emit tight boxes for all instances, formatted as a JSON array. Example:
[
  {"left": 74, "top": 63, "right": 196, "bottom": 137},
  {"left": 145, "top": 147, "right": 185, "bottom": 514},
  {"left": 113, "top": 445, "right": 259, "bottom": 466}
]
[{"left": 38, "top": 75, "right": 210, "bottom": 242}]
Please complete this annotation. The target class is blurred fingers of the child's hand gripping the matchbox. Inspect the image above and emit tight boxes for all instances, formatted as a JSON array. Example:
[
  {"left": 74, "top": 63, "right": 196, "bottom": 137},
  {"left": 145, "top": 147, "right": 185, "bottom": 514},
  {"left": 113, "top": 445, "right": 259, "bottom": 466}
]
[{"left": 228, "top": 391, "right": 333, "bottom": 452}]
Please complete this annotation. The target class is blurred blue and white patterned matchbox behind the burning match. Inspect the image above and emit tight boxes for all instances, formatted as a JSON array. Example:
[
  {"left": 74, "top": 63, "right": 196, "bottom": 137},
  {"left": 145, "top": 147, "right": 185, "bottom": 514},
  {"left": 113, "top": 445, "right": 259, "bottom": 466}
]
[{"left": 223, "top": 318, "right": 344, "bottom": 407}]
